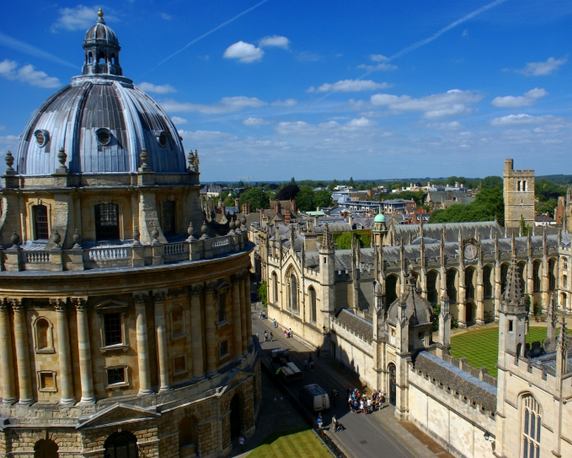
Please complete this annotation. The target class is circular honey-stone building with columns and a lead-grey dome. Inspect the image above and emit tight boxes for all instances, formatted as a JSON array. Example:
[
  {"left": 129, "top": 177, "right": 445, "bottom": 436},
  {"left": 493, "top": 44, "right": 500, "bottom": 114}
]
[{"left": 0, "top": 10, "right": 260, "bottom": 457}]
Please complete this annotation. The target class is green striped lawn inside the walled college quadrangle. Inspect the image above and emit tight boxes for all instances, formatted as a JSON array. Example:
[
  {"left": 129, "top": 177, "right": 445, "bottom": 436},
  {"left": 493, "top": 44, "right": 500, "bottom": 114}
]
[{"left": 451, "top": 326, "right": 560, "bottom": 377}]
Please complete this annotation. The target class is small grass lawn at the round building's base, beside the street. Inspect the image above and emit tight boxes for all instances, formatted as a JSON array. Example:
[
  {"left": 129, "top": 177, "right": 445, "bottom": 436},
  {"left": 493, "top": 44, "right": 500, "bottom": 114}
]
[{"left": 248, "top": 429, "right": 332, "bottom": 458}]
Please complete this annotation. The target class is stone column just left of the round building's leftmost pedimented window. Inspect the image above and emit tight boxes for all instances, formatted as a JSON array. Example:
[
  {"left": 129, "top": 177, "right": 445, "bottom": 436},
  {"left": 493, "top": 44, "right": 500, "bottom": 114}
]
[{"left": 72, "top": 297, "right": 95, "bottom": 404}]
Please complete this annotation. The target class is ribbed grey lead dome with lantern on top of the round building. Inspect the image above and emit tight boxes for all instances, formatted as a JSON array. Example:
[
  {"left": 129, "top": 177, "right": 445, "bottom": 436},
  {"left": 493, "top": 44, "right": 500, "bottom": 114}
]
[{"left": 15, "top": 10, "right": 186, "bottom": 176}]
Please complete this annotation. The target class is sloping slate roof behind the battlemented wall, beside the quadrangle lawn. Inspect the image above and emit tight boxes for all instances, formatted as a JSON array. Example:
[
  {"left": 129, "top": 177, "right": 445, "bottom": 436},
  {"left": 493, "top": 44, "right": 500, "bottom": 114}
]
[{"left": 415, "top": 351, "right": 497, "bottom": 412}]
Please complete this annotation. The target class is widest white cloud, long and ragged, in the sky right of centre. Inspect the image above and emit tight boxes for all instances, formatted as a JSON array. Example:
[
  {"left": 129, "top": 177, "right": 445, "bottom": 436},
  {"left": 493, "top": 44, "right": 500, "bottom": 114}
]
[{"left": 370, "top": 89, "right": 483, "bottom": 119}]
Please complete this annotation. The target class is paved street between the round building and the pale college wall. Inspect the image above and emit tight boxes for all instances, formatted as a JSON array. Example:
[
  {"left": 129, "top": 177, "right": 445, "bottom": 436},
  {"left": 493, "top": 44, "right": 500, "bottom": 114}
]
[{"left": 253, "top": 313, "right": 452, "bottom": 458}]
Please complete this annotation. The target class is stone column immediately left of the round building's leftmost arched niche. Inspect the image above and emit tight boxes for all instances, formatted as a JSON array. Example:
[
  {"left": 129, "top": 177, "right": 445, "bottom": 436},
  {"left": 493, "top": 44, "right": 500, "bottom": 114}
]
[{"left": 8, "top": 298, "right": 34, "bottom": 405}]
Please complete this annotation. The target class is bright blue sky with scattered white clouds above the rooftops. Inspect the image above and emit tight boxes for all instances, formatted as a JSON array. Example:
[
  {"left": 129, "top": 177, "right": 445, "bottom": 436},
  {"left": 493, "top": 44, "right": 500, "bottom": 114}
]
[{"left": 0, "top": 0, "right": 572, "bottom": 181}]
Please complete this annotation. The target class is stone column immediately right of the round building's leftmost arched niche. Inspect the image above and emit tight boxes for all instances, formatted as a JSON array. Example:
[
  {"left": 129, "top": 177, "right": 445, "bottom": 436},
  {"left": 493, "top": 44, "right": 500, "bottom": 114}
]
[{"left": 50, "top": 298, "right": 75, "bottom": 405}]
